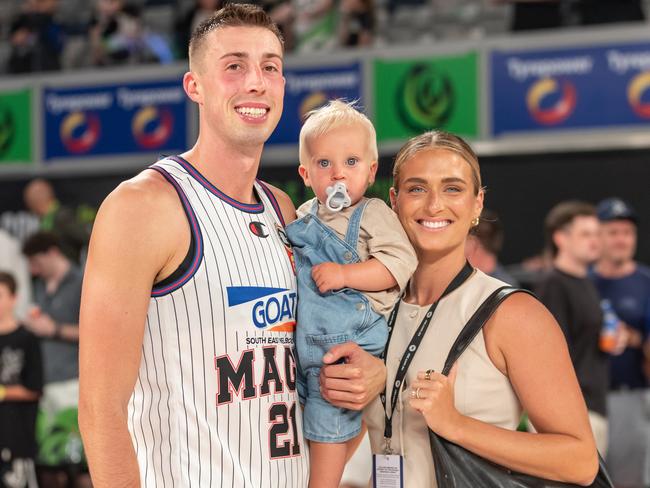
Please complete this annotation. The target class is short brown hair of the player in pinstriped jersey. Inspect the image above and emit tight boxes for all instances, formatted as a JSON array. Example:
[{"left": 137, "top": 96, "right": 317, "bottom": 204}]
[{"left": 189, "top": 3, "right": 284, "bottom": 65}]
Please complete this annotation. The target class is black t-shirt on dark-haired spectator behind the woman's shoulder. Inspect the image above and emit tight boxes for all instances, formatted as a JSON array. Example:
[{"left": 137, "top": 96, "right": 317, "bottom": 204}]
[{"left": 536, "top": 269, "right": 609, "bottom": 416}]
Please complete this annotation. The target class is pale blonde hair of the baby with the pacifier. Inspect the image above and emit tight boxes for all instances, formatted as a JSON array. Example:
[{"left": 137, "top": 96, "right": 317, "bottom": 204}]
[{"left": 298, "top": 99, "right": 379, "bottom": 166}]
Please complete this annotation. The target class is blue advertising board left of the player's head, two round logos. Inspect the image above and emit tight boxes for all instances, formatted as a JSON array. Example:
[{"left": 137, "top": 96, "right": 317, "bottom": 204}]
[{"left": 43, "top": 79, "right": 187, "bottom": 160}]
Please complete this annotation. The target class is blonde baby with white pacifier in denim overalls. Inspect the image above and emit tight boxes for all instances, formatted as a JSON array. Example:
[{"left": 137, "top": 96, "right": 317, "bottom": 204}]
[{"left": 286, "top": 100, "right": 417, "bottom": 488}]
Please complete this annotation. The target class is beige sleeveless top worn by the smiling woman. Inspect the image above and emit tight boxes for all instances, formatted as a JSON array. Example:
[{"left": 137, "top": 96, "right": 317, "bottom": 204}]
[{"left": 364, "top": 270, "right": 521, "bottom": 488}]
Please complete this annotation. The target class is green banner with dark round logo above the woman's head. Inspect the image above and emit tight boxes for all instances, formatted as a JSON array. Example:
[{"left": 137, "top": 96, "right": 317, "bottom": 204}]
[{"left": 374, "top": 52, "right": 478, "bottom": 141}]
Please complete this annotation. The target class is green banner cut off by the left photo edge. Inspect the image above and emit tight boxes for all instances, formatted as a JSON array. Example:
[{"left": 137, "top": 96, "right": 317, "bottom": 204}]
[{"left": 0, "top": 90, "right": 32, "bottom": 164}]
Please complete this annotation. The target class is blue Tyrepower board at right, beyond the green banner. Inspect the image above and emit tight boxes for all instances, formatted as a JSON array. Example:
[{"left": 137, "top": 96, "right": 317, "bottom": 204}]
[{"left": 491, "top": 43, "right": 650, "bottom": 135}]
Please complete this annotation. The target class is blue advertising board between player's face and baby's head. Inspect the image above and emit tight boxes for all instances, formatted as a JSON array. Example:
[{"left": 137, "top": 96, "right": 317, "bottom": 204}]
[{"left": 268, "top": 62, "right": 363, "bottom": 144}]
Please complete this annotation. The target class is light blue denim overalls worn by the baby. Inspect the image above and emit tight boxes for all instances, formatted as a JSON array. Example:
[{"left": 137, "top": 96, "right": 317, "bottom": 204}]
[{"left": 286, "top": 200, "right": 388, "bottom": 443}]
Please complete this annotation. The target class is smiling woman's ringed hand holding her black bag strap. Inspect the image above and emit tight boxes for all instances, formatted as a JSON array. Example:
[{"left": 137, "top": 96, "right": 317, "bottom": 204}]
[{"left": 409, "top": 363, "right": 462, "bottom": 441}]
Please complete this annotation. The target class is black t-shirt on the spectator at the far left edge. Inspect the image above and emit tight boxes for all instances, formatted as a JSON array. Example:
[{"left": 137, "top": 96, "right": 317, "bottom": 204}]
[{"left": 0, "top": 327, "right": 43, "bottom": 461}]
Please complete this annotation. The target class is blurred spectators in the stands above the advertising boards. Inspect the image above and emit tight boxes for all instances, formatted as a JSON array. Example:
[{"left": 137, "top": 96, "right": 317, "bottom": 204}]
[{"left": 0, "top": 0, "right": 648, "bottom": 73}]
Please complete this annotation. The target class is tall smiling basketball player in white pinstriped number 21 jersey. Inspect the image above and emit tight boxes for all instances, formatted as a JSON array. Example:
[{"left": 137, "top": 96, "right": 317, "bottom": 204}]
[{"left": 80, "top": 4, "right": 385, "bottom": 488}]
